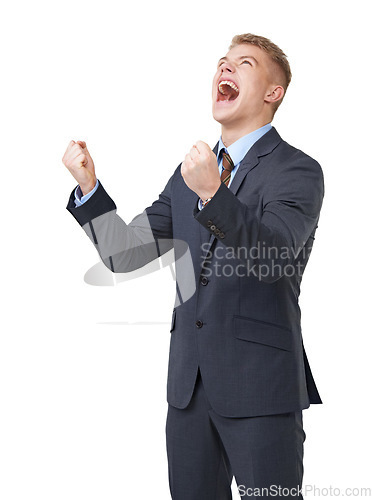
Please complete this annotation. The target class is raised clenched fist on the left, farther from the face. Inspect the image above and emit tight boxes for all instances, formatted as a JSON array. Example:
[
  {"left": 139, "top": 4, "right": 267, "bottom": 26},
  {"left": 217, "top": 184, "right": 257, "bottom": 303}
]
[{"left": 62, "top": 141, "right": 97, "bottom": 195}]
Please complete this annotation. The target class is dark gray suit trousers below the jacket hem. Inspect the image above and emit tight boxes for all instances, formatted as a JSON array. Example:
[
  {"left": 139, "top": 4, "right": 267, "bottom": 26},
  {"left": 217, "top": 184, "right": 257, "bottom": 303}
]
[{"left": 166, "top": 371, "right": 306, "bottom": 500}]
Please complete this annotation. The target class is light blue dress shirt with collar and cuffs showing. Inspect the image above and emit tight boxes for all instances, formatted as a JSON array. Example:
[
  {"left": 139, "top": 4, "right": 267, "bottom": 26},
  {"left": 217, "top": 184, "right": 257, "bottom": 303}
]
[{"left": 75, "top": 123, "right": 271, "bottom": 210}]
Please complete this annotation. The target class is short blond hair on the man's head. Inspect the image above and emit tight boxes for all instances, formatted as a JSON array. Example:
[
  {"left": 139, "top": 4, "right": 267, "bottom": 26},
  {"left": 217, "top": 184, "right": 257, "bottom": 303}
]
[{"left": 229, "top": 33, "right": 292, "bottom": 116}]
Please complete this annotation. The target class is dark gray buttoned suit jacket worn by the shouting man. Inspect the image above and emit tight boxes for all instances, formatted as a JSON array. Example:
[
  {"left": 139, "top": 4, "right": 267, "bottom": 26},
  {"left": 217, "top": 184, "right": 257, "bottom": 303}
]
[{"left": 67, "top": 127, "right": 324, "bottom": 417}]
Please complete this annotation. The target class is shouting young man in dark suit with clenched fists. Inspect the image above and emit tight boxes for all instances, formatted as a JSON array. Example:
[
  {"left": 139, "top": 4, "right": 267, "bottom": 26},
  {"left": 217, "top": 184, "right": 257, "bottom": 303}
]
[{"left": 63, "top": 34, "right": 324, "bottom": 500}]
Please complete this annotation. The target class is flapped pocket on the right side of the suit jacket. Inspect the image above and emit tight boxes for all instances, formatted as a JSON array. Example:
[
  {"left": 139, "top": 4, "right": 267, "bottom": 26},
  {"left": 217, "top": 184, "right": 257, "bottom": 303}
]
[{"left": 234, "top": 316, "right": 292, "bottom": 351}]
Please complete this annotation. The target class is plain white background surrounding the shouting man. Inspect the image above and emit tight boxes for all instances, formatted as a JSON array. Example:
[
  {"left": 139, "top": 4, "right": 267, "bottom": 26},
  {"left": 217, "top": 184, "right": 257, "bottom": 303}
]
[{"left": 0, "top": 0, "right": 372, "bottom": 500}]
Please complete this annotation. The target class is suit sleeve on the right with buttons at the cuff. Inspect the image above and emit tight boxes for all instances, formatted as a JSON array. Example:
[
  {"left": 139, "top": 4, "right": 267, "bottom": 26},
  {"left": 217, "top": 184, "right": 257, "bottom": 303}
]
[{"left": 194, "top": 155, "right": 324, "bottom": 282}]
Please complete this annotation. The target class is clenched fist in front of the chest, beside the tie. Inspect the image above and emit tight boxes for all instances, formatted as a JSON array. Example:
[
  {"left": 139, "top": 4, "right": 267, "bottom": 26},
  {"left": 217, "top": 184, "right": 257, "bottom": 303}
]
[{"left": 181, "top": 141, "right": 221, "bottom": 200}]
